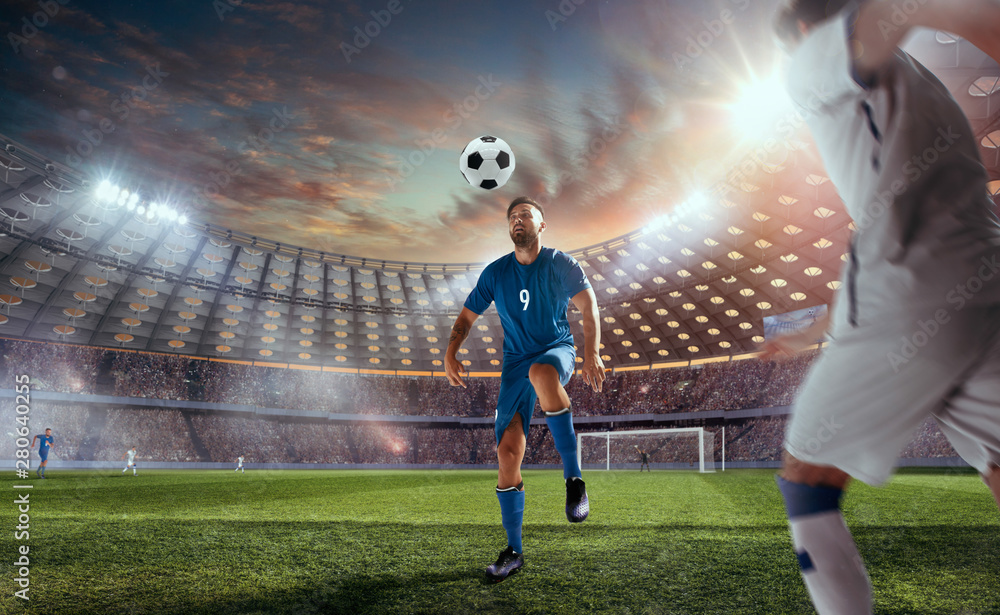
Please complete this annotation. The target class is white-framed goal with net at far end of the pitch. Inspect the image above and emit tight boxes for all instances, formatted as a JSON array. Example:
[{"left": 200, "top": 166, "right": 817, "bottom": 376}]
[{"left": 576, "top": 427, "right": 725, "bottom": 472}]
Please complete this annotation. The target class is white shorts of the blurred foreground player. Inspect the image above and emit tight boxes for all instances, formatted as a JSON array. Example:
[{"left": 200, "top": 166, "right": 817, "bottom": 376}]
[{"left": 785, "top": 306, "right": 1000, "bottom": 485}]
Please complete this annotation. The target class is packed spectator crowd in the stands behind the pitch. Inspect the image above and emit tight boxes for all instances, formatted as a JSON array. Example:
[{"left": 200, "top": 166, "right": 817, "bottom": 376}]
[{"left": 0, "top": 340, "right": 957, "bottom": 465}]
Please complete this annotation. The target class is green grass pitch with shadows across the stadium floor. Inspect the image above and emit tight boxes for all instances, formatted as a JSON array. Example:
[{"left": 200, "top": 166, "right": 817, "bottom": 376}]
[{"left": 0, "top": 468, "right": 1000, "bottom": 615}]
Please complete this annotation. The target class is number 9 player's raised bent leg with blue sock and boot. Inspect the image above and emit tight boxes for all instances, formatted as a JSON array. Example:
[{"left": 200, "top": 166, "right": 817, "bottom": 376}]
[{"left": 528, "top": 363, "right": 590, "bottom": 523}]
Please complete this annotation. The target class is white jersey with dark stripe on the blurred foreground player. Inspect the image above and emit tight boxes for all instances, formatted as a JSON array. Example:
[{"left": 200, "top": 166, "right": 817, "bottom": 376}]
[{"left": 788, "top": 11, "right": 1000, "bottom": 325}]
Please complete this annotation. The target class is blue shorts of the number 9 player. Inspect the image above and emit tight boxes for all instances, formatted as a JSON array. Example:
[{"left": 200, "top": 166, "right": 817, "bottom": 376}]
[{"left": 493, "top": 346, "right": 576, "bottom": 446}]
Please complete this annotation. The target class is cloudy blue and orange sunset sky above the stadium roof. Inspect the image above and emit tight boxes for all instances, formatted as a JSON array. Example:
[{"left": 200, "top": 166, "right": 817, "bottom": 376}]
[{"left": 0, "top": 0, "right": 777, "bottom": 263}]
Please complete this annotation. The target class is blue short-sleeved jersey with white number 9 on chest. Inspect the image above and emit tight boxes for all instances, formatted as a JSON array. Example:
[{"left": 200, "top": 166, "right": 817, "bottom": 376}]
[{"left": 465, "top": 248, "right": 591, "bottom": 363}]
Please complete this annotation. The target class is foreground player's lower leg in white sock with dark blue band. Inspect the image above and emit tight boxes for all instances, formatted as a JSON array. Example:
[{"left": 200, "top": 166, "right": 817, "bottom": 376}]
[{"left": 778, "top": 452, "right": 872, "bottom": 615}]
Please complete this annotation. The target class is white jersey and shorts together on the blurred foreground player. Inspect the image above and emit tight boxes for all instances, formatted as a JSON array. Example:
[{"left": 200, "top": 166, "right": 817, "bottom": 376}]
[{"left": 785, "top": 11, "right": 1000, "bottom": 485}]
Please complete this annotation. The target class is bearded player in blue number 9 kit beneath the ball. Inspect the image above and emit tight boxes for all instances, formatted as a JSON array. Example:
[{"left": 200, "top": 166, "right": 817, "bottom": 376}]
[{"left": 445, "top": 197, "right": 605, "bottom": 582}]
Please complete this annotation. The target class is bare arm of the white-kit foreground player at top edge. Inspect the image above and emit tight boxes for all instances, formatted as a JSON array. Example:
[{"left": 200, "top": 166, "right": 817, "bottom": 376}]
[{"left": 851, "top": 0, "right": 1000, "bottom": 83}]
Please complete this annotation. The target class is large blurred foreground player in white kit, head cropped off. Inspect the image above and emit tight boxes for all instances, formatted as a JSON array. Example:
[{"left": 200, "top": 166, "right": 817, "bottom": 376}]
[{"left": 764, "top": 0, "right": 1000, "bottom": 615}]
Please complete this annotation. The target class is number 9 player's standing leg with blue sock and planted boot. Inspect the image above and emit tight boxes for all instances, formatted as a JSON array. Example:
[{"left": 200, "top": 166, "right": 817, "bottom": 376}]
[{"left": 486, "top": 412, "right": 527, "bottom": 583}]
